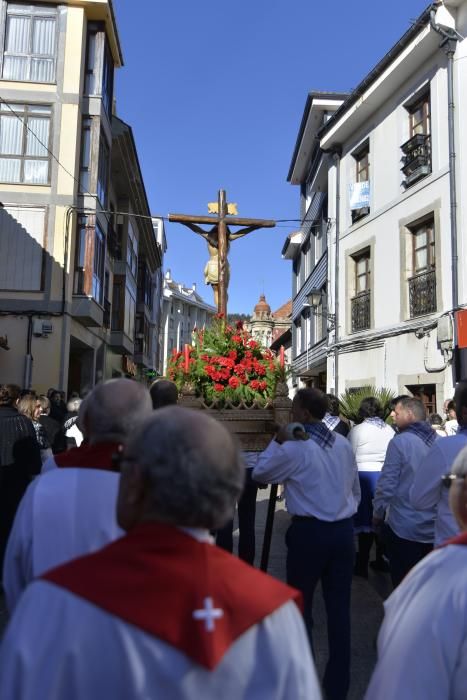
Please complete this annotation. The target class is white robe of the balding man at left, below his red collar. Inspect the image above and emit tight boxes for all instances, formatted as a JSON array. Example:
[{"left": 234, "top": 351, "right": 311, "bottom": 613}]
[{"left": 3, "top": 467, "right": 123, "bottom": 612}]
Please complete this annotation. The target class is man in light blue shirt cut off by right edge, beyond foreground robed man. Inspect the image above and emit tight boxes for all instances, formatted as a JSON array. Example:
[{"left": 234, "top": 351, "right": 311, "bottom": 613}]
[{"left": 410, "top": 382, "right": 467, "bottom": 546}]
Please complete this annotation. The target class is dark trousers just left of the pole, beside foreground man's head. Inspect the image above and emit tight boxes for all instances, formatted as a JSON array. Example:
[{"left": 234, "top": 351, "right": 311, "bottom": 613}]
[{"left": 216, "top": 469, "right": 258, "bottom": 565}]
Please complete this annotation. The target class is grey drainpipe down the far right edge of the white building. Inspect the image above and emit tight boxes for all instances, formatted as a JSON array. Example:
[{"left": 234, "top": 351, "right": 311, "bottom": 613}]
[{"left": 430, "top": 8, "right": 462, "bottom": 382}]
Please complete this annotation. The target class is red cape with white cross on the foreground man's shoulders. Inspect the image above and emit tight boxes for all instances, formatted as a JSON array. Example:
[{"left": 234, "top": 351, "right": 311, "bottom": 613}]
[{"left": 43, "top": 522, "right": 301, "bottom": 669}]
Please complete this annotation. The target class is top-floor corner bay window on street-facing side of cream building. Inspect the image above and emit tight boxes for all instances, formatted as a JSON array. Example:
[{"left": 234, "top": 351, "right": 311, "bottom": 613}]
[{"left": 84, "top": 22, "right": 114, "bottom": 118}]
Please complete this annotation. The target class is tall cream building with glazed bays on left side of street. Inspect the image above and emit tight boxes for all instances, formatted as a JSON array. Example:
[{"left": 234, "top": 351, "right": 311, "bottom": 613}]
[{"left": 0, "top": 0, "right": 162, "bottom": 392}]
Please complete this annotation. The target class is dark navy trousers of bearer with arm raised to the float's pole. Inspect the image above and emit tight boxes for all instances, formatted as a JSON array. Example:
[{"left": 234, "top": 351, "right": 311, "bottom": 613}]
[{"left": 286, "top": 518, "right": 354, "bottom": 700}]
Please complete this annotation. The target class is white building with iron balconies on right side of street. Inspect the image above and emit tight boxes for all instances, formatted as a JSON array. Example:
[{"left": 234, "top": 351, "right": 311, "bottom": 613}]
[{"left": 284, "top": 0, "right": 467, "bottom": 411}]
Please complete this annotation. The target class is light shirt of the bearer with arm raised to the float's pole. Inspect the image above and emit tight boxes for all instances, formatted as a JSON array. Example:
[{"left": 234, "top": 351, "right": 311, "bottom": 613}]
[{"left": 253, "top": 433, "right": 360, "bottom": 522}]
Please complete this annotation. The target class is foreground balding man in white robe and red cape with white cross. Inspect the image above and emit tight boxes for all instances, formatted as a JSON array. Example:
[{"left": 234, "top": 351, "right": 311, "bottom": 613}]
[{"left": 0, "top": 406, "right": 320, "bottom": 700}]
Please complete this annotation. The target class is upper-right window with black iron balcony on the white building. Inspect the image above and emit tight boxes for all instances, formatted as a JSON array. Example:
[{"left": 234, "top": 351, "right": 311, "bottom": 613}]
[{"left": 401, "top": 92, "right": 431, "bottom": 188}]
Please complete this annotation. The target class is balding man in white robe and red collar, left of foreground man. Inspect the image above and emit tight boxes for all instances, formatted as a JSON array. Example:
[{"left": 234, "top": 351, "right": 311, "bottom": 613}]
[{"left": 3, "top": 379, "right": 151, "bottom": 611}]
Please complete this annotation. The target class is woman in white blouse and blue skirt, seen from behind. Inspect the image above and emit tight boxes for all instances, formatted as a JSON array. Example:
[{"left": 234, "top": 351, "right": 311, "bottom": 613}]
[{"left": 349, "top": 397, "right": 394, "bottom": 578}]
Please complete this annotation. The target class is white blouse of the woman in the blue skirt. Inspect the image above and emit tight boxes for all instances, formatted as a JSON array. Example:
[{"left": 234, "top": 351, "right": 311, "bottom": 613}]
[{"left": 349, "top": 421, "right": 395, "bottom": 472}]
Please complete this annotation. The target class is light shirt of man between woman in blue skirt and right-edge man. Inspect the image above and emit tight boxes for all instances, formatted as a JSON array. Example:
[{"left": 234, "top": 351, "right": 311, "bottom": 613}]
[{"left": 373, "top": 431, "right": 436, "bottom": 543}]
